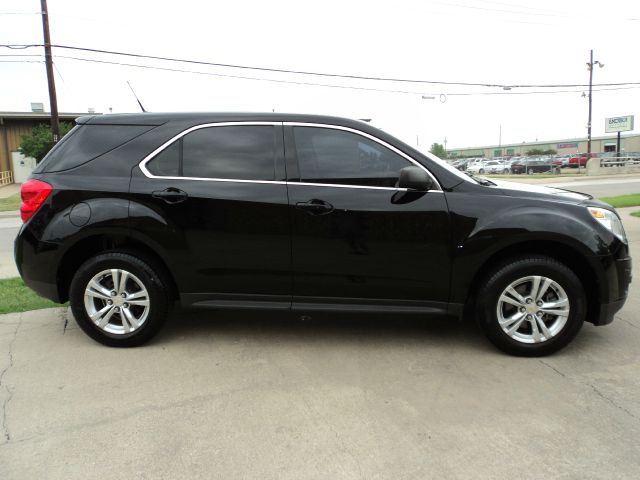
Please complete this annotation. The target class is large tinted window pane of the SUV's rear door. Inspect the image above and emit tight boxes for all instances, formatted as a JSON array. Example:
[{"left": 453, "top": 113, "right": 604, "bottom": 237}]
[{"left": 182, "top": 125, "right": 276, "bottom": 180}]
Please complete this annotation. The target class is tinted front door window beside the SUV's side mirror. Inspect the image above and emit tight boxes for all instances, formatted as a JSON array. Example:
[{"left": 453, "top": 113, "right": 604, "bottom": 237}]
[{"left": 293, "top": 127, "right": 411, "bottom": 187}]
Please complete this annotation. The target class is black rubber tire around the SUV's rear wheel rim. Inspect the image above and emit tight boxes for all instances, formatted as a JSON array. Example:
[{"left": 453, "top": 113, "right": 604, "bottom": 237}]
[{"left": 69, "top": 252, "right": 171, "bottom": 347}]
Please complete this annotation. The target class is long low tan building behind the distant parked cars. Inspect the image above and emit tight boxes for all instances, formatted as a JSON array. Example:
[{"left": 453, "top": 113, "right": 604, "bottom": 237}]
[{"left": 447, "top": 133, "right": 640, "bottom": 158}]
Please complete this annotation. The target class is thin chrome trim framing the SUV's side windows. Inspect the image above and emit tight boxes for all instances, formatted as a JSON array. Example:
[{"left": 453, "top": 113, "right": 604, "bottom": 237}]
[{"left": 138, "top": 121, "right": 443, "bottom": 193}]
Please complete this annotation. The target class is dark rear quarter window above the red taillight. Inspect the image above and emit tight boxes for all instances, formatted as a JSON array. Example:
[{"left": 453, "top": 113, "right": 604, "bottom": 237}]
[{"left": 34, "top": 125, "right": 153, "bottom": 173}]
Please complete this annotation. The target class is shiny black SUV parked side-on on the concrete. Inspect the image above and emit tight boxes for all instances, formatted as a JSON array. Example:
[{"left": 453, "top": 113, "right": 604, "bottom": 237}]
[{"left": 15, "top": 113, "right": 631, "bottom": 355}]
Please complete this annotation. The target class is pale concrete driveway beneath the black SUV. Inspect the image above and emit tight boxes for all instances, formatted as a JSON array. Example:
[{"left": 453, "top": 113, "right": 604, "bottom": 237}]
[{"left": 0, "top": 216, "right": 640, "bottom": 480}]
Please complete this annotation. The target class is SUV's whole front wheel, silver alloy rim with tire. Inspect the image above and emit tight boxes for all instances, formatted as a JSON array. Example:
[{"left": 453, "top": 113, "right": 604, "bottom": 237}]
[{"left": 478, "top": 256, "right": 586, "bottom": 356}]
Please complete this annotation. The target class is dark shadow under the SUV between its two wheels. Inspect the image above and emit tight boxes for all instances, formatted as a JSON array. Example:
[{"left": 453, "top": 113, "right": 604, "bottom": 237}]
[{"left": 152, "top": 307, "right": 497, "bottom": 352}]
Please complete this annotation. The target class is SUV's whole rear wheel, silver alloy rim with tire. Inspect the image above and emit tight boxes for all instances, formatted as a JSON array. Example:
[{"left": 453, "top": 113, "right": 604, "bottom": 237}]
[{"left": 69, "top": 252, "right": 170, "bottom": 347}]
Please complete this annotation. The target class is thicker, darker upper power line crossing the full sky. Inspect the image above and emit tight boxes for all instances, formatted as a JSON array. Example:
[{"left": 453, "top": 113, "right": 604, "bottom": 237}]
[{"left": 5, "top": 44, "right": 640, "bottom": 88}]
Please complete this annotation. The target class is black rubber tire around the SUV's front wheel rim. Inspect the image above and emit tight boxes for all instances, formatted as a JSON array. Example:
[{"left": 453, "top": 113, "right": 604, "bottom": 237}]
[{"left": 477, "top": 255, "right": 586, "bottom": 357}]
